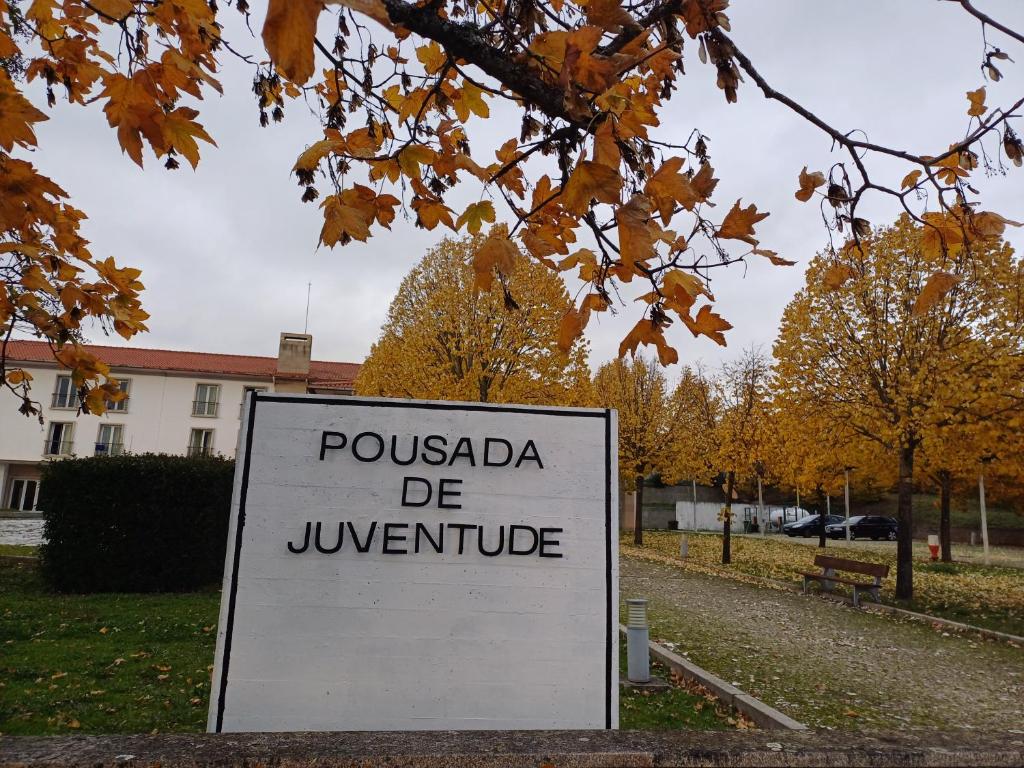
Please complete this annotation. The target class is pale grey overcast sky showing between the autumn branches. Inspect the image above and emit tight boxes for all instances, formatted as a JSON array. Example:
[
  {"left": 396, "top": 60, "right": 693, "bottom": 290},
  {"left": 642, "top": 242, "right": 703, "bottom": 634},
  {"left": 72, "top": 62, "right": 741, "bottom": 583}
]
[{"left": 22, "top": 0, "right": 1024, "bottom": 378}]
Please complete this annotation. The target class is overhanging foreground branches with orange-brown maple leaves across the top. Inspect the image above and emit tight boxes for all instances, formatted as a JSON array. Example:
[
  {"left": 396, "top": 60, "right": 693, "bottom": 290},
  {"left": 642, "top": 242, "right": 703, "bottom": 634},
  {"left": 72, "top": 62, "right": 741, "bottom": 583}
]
[{"left": 0, "top": 0, "right": 1024, "bottom": 411}]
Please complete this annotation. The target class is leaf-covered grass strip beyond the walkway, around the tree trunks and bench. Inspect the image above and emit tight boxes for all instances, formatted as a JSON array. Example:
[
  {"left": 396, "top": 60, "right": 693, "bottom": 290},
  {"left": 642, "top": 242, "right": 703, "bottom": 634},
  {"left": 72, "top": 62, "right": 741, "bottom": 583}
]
[{"left": 621, "top": 530, "right": 1024, "bottom": 635}]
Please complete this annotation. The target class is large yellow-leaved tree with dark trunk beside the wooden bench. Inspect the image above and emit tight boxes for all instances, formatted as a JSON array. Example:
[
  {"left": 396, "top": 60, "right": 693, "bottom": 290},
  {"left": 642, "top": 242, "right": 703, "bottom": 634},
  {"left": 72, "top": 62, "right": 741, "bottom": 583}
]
[{"left": 774, "top": 216, "right": 1024, "bottom": 598}]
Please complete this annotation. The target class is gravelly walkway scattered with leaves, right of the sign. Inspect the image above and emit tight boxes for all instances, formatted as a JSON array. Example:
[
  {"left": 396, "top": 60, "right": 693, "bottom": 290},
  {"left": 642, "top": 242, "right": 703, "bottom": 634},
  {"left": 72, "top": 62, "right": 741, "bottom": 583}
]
[{"left": 620, "top": 557, "right": 1024, "bottom": 732}]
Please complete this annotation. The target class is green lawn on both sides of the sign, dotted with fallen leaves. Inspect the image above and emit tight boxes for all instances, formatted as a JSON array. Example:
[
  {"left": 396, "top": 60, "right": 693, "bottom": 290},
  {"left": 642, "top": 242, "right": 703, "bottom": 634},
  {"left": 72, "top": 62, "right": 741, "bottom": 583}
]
[{"left": 0, "top": 553, "right": 749, "bottom": 735}]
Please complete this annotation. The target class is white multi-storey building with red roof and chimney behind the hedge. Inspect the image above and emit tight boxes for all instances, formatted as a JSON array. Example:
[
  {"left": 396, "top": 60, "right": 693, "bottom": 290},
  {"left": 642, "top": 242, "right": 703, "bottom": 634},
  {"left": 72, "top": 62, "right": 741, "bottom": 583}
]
[{"left": 0, "top": 334, "right": 359, "bottom": 510}]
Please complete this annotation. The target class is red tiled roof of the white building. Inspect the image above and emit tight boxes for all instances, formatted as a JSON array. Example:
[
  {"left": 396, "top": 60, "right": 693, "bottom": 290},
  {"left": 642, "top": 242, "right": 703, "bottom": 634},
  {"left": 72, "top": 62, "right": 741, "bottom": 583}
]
[{"left": 7, "top": 339, "right": 359, "bottom": 385}]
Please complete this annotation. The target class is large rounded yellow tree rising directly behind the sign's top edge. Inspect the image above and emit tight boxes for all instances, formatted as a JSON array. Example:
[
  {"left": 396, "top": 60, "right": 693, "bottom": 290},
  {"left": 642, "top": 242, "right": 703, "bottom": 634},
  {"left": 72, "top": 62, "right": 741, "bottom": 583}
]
[{"left": 355, "top": 236, "right": 590, "bottom": 406}]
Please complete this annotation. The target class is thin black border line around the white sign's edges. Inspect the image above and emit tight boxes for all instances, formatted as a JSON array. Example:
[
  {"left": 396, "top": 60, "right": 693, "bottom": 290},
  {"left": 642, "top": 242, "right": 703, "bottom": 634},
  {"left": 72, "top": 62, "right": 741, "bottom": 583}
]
[{"left": 214, "top": 391, "right": 617, "bottom": 733}]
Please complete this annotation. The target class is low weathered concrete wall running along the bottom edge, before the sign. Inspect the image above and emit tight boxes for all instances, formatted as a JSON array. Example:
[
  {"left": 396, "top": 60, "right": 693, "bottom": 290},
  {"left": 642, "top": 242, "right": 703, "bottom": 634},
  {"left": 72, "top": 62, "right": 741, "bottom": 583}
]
[{"left": 0, "top": 729, "right": 1024, "bottom": 768}]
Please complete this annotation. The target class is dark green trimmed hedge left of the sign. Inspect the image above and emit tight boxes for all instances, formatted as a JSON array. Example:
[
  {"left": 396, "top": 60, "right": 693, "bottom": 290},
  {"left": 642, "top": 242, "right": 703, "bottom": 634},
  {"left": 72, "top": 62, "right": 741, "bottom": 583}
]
[{"left": 39, "top": 454, "right": 234, "bottom": 593}]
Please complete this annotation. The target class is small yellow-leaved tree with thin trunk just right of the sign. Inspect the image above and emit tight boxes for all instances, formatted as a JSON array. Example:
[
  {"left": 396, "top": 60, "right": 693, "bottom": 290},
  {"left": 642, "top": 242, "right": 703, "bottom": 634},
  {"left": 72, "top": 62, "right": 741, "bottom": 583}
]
[{"left": 594, "top": 354, "right": 690, "bottom": 546}]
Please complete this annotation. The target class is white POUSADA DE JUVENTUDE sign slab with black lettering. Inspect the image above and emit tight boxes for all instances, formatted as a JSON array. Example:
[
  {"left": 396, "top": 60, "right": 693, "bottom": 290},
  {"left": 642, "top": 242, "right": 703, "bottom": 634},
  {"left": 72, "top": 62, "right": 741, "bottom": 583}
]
[{"left": 208, "top": 392, "right": 618, "bottom": 732}]
